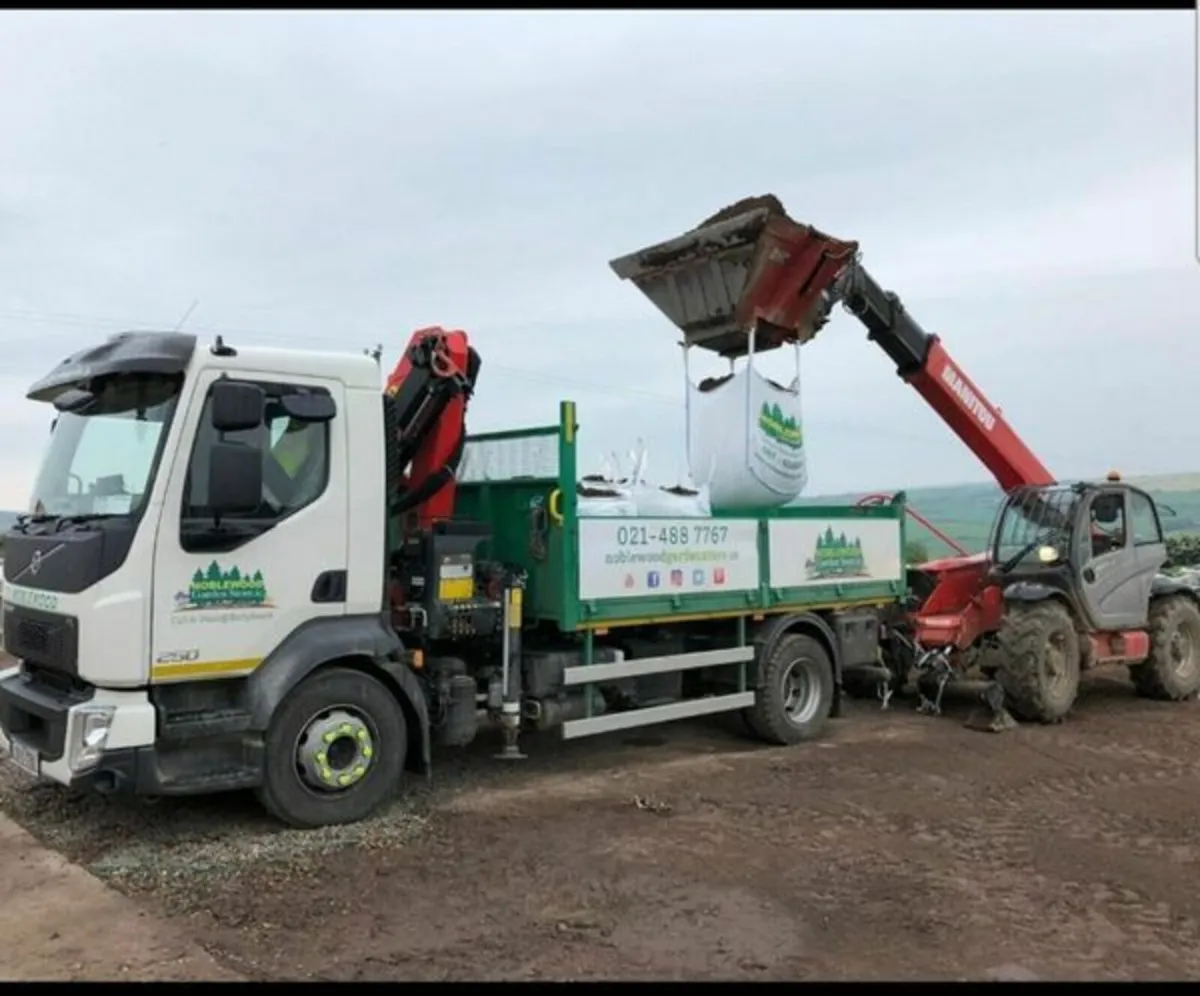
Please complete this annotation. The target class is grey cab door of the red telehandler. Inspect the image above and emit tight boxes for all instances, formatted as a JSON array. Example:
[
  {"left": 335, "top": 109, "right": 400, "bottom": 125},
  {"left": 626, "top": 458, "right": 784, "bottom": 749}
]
[{"left": 1079, "top": 490, "right": 1165, "bottom": 630}]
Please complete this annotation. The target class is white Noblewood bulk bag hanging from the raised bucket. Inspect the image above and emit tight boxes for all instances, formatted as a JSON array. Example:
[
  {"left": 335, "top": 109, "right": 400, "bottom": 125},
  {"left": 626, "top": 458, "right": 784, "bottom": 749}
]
[{"left": 685, "top": 350, "right": 808, "bottom": 509}]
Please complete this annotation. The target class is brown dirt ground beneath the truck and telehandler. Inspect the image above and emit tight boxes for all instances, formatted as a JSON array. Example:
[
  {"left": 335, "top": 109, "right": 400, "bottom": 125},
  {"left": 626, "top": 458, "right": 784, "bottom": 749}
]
[{"left": 0, "top": 679, "right": 1200, "bottom": 980}]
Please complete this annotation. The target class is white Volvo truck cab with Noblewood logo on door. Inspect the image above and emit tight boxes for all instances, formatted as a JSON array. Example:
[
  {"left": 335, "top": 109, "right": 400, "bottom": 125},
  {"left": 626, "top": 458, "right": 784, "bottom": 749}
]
[{"left": 0, "top": 332, "right": 428, "bottom": 823}]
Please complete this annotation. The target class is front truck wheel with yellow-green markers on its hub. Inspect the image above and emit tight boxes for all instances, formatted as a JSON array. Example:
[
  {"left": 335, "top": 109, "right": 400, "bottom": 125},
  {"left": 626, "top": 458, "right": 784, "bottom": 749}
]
[{"left": 258, "top": 667, "right": 408, "bottom": 829}]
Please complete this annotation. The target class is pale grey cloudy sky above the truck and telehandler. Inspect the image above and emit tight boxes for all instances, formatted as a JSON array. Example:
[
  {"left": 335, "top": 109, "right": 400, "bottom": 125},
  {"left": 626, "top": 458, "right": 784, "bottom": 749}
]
[{"left": 0, "top": 12, "right": 1200, "bottom": 508}]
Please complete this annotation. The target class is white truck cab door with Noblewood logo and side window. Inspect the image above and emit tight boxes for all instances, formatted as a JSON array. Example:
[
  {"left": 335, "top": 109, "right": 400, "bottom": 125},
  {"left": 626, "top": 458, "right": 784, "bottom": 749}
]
[{"left": 149, "top": 372, "right": 348, "bottom": 682}]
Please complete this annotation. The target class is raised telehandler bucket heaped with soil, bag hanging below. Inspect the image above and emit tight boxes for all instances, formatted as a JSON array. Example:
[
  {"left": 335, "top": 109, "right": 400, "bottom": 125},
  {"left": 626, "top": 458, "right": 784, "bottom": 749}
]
[{"left": 608, "top": 194, "right": 858, "bottom": 358}]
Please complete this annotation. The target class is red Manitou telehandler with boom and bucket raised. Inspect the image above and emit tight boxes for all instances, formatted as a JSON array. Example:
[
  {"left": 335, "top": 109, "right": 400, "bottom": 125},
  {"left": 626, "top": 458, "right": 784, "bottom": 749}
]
[{"left": 611, "top": 196, "right": 1200, "bottom": 730}]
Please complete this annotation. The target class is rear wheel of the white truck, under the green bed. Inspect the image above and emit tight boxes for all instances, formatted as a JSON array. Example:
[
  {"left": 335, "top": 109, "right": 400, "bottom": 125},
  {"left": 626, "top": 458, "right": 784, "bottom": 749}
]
[{"left": 743, "top": 632, "right": 834, "bottom": 745}]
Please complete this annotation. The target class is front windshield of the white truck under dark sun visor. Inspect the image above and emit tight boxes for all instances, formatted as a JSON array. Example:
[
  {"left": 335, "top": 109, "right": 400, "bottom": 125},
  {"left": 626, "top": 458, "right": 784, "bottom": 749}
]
[{"left": 30, "top": 376, "right": 182, "bottom": 517}]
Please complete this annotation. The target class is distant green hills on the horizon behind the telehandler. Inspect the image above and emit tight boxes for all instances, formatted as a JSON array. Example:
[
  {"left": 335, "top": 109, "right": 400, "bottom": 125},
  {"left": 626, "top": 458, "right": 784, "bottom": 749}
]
[{"left": 797, "top": 474, "right": 1200, "bottom": 557}]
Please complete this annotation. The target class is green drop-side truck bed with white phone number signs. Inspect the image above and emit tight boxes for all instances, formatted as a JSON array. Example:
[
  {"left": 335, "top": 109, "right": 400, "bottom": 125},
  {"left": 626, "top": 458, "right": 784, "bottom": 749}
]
[{"left": 457, "top": 401, "right": 906, "bottom": 631}]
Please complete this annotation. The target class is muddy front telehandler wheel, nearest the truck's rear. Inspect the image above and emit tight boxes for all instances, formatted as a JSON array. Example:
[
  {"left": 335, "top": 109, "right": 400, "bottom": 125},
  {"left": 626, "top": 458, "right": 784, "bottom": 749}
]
[{"left": 996, "top": 601, "right": 1080, "bottom": 722}]
